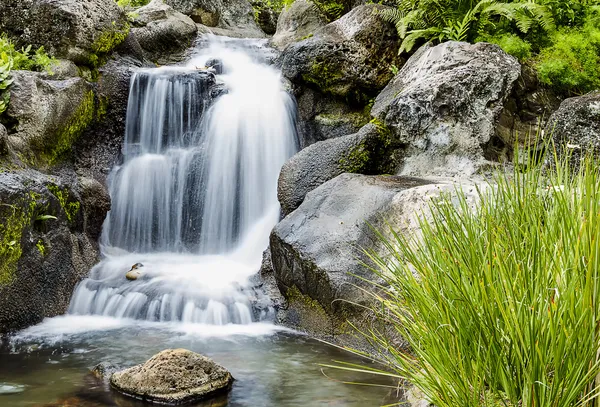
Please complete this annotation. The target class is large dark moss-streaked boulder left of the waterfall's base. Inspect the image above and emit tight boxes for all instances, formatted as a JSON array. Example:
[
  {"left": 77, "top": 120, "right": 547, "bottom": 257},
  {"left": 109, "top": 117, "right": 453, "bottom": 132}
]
[{"left": 0, "top": 169, "right": 110, "bottom": 332}]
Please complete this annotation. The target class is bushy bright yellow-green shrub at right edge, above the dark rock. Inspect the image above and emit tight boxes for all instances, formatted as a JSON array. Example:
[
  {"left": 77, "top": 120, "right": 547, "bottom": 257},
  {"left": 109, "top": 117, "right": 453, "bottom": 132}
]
[{"left": 536, "top": 24, "right": 600, "bottom": 93}]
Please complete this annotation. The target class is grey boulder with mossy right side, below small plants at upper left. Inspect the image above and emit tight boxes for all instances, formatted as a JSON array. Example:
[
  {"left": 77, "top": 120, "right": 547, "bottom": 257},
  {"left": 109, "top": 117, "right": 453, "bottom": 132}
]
[{"left": 5, "top": 71, "right": 98, "bottom": 165}]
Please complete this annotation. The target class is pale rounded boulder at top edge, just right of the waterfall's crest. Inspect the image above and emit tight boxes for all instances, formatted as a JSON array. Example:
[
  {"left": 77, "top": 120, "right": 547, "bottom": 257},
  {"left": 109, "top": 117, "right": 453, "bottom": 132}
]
[{"left": 271, "top": 0, "right": 327, "bottom": 51}]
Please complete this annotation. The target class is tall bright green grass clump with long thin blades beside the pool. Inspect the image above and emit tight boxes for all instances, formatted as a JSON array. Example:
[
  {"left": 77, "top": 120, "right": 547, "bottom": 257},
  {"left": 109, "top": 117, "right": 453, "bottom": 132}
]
[{"left": 336, "top": 146, "right": 600, "bottom": 407}]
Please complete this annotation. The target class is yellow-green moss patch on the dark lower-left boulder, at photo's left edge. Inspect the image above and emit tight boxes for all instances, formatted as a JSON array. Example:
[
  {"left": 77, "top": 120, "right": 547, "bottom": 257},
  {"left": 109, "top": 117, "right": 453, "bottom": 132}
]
[{"left": 0, "top": 192, "right": 39, "bottom": 285}]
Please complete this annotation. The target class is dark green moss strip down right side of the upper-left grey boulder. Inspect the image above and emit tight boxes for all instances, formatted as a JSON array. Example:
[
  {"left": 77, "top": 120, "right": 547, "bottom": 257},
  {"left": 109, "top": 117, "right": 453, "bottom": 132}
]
[{"left": 43, "top": 90, "right": 96, "bottom": 165}]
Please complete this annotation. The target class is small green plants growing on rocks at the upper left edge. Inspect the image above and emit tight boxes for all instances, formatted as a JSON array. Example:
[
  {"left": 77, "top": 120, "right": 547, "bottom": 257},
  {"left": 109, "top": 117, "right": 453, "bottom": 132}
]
[{"left": 0, "top": 34, "right": 56, "bottom": 114}]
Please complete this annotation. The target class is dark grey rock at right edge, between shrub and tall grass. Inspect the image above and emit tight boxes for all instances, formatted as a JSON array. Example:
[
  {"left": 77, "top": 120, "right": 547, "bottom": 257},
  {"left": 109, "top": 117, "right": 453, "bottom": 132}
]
[{"left": 544, "top": 92, "right": 600, "bottom": 168}]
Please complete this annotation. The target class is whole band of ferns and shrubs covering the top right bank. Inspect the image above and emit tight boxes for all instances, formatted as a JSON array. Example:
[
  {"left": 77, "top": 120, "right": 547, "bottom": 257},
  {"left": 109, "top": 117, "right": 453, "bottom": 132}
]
[{"left": 381, "top": 0, "right": 600, "bottom": 96}]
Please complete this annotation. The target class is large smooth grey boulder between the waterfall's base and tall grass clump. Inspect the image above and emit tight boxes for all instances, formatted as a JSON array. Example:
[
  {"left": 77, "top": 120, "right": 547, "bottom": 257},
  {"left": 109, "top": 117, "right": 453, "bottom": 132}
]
[{"left": 270, "top": 174, "right": 477, "bottom": 340}]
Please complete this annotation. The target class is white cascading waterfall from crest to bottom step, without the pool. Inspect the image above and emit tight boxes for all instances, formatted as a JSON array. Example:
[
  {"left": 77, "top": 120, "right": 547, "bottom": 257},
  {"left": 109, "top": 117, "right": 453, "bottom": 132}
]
[{"left": 69, "top": 36, "right": 296, "bottom": 325}]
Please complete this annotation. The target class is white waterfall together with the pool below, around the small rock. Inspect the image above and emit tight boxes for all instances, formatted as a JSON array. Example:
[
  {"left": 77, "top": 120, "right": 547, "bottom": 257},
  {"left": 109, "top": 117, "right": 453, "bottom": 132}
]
[{"left": 0, "top": 39, "right": 388, "bottom": 407}]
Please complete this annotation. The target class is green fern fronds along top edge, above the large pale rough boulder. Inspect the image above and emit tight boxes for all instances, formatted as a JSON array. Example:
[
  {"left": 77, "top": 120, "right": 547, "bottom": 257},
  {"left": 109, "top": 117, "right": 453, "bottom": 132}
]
[{"left": 380, "top": 0, "right": 554, "bottom": 53}]
